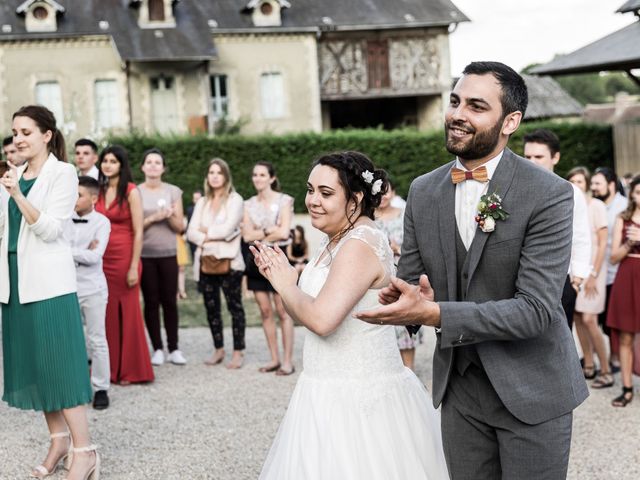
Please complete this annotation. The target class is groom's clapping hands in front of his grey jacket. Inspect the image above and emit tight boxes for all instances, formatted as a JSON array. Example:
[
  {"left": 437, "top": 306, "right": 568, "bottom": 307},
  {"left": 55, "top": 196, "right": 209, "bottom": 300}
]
[{"left": 353, "top": 275, "right": 440, "bottom": 327}]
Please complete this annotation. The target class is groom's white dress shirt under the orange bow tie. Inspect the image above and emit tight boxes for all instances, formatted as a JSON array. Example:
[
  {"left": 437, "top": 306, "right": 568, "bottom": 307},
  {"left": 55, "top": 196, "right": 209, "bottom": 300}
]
[{"left": 456, "top": 150, "right": 504, "bottom": 250}]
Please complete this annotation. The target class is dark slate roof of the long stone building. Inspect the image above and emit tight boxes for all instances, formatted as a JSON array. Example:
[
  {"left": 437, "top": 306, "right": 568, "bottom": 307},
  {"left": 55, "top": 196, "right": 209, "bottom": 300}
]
[{"left": 0, "top": 0, "right": 468, "bottom": 62}]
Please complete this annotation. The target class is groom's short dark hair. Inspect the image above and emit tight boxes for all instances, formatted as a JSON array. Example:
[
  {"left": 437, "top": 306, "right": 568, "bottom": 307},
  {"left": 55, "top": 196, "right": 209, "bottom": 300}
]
[{"left": 462, "top": 62, "right": 529, "bottom": 117}]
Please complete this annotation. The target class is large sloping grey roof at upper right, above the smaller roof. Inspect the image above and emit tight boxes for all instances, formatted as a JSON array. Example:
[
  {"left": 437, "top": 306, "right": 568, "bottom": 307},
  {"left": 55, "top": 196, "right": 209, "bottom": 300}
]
[{"left": 531, "top": 20, "right": 640, "bottom": 74}]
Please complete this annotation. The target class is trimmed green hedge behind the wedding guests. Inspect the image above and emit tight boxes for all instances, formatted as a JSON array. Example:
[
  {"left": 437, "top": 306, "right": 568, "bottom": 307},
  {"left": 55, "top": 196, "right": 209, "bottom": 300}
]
[{"left": 110, "top": 123, "right": 613, "bottom": 212}]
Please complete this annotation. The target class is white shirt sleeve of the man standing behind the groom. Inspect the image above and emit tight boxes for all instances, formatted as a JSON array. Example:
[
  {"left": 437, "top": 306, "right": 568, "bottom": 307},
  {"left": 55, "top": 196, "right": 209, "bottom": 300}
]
[{"left": 569, "top": 183, "right": 591, "bottom": 279}]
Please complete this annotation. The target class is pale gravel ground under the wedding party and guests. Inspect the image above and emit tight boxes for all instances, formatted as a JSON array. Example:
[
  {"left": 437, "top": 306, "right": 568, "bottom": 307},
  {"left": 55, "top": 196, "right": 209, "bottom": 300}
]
[{"left": 0, "top": 328, "right": 640, "bottom": 480}]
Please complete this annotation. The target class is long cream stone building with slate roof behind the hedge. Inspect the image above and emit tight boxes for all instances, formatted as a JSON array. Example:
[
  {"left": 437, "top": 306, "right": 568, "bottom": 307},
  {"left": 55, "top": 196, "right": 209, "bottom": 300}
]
[{"left": 0, "top": 0, "right": 467, "bottom": 137}]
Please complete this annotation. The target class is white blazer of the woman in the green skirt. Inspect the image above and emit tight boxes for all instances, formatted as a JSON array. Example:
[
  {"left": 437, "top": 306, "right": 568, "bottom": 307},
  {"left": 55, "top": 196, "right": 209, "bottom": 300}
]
[{"left": 0, "top": 154, "right": 78, "bottom": 303}]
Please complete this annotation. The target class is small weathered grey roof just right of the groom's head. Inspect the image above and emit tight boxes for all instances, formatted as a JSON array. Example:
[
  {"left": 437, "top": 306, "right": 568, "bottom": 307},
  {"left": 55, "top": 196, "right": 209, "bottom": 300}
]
[{"left": 523, "top": 75, "right": 584, "bottom": 120}]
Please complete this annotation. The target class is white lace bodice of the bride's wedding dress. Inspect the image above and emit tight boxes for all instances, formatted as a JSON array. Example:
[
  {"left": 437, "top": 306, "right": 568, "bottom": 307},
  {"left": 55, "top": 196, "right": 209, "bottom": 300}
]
[{"left": 300, "top": 225, "right": 404, "bottom": 382}]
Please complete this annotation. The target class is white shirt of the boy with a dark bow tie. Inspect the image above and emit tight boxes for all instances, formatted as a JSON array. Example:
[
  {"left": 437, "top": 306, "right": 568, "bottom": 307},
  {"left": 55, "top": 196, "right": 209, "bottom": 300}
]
[{"left": 65, "top": 210, "right": 111, "bottom": 298}]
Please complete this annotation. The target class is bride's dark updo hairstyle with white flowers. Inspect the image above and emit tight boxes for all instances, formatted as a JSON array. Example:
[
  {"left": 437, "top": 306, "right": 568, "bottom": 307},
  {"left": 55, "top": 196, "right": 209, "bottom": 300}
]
[{"left": 311, "top": 151, "right": 389, "bottom": 224}]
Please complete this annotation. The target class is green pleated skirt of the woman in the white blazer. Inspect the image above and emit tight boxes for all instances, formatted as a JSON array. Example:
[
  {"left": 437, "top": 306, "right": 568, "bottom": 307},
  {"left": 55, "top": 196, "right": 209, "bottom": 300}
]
[{"left": 2, "top": 253, "right": 92, "bottom": 412}]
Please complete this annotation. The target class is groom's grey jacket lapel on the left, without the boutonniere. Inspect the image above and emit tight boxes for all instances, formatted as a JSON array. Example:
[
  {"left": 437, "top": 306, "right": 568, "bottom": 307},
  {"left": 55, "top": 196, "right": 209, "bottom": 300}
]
[{"left": 435, "top": 161, "right": 458, "bottom": 301}]
